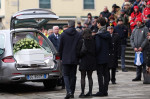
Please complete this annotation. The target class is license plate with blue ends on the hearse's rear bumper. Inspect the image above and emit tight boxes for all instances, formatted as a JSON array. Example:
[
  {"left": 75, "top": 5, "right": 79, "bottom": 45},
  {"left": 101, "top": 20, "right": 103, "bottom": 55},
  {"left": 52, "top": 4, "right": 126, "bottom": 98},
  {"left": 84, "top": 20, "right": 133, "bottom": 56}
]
[{"left": 26, "top": 74, "right": 48, "bottom": 80}]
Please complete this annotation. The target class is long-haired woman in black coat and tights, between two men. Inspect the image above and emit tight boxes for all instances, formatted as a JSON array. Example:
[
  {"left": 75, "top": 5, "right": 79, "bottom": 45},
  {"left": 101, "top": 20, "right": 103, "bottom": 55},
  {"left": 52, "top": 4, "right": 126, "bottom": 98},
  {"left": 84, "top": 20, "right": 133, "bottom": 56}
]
[{"left": 79, "top": 29, "right": 96, "bottom": 98}]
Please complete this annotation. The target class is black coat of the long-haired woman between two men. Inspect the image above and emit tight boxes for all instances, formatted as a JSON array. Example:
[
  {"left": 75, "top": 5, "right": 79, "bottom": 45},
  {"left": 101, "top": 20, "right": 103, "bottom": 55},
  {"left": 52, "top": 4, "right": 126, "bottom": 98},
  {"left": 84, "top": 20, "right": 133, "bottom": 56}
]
[{"left": 78, "top": 38, "right": 96, "bottom": 71}]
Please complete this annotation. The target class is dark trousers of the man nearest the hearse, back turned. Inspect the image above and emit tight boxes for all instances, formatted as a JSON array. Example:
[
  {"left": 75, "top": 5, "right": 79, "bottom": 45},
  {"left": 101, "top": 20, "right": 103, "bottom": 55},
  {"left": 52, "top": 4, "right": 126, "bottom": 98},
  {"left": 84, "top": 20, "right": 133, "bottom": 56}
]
[{"left": 63, "top": 64, "right": 77, "bottom": 94}]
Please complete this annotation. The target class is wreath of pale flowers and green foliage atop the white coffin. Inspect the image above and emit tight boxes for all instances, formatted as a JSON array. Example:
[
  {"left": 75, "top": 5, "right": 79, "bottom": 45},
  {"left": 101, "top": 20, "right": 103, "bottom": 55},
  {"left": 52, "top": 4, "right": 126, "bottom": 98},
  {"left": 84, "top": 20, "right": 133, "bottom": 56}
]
[{"left": 13, "top": 38, "right": 41, "bottom": 53}]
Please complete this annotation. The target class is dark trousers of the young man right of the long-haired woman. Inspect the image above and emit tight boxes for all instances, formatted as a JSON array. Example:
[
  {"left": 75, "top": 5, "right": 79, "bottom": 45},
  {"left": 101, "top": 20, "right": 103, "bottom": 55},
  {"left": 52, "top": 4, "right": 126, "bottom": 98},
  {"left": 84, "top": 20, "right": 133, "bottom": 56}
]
[{"left": 97, "top": 64, "right": 109, "bottom": 94}]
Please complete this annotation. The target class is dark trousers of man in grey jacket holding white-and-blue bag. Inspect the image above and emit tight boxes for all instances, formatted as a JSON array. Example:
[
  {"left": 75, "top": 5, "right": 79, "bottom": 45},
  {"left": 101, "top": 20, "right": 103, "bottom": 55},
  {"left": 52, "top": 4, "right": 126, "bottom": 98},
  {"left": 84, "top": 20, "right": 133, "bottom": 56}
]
[{"left": 136, "top": 50, "right": 147, "bottom": 79}]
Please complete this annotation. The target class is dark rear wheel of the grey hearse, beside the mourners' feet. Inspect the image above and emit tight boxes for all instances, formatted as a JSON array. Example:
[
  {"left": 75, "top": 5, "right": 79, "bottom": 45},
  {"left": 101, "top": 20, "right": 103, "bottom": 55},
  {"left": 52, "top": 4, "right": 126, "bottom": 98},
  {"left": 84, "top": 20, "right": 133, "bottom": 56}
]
[{"left": 43, "top": 79, "right": 57, "bottom": 89}]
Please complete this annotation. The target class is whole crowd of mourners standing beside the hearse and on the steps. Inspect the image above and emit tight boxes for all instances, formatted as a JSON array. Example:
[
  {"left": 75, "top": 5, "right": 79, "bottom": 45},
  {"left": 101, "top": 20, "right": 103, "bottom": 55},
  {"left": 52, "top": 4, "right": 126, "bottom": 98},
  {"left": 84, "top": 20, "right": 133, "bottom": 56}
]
[{"left": 40, "top": 0, "right": 150, "bottom": 99}]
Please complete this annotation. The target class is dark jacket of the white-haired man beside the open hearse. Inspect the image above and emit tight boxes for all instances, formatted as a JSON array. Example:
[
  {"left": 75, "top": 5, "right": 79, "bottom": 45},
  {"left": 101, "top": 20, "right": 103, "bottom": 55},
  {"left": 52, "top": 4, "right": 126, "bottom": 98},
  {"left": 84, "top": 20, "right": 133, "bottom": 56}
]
[{"left": 48, "top": 33, "right": 60, "bottom": 51}]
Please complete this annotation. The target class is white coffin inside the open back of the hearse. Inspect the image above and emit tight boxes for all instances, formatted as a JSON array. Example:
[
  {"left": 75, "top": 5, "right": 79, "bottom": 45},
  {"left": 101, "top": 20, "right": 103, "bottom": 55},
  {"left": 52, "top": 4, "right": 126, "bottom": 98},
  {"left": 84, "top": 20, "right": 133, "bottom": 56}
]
[{"left": 14, "top": 49, "right": 44, "bottom": 65}]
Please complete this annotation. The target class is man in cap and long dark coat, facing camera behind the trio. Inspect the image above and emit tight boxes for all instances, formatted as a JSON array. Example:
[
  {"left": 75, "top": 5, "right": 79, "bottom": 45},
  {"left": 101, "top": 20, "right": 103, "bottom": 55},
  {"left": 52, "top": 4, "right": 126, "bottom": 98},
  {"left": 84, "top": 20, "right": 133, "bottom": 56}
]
[{"left": 107, "top": 26, "right": 121, "bottom": 84}]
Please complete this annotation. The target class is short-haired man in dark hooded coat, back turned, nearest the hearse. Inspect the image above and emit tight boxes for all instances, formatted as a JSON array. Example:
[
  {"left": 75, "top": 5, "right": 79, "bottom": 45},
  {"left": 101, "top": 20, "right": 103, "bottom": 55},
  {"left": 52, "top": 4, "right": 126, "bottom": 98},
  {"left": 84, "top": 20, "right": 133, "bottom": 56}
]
[{"left": 59, "top": 21, "right": 81, "bottom": 99}]
